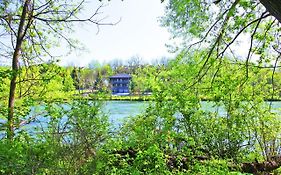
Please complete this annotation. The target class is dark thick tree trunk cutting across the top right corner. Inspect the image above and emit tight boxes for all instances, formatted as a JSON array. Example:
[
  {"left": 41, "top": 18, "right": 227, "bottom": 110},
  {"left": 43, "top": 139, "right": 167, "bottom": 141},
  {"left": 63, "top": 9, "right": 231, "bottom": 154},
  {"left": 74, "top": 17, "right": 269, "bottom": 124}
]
[{"left": 260, "top": 0, "right": 281, "bottom": 23}]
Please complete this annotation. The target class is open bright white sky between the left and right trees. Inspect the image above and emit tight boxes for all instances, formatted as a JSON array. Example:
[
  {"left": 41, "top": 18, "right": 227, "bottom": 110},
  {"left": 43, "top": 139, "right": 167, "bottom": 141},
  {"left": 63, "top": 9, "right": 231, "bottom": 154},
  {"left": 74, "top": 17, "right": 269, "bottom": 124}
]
[{"left": 61, "top": 0, "right": 173, "bottom": 66}]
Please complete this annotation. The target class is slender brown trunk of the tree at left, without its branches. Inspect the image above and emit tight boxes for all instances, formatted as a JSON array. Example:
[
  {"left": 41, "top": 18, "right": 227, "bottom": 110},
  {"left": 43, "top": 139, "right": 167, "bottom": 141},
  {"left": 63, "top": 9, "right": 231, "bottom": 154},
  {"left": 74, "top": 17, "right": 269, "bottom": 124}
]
[{"left": 7, "top": 0, "right": 31, "bottom": 140}]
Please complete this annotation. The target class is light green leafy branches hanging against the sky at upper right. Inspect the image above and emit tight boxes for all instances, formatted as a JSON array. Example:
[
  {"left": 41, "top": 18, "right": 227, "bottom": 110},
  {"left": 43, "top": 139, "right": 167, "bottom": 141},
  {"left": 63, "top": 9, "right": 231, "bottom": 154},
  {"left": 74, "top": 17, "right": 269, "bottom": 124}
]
[{"left": 162, "top": 0, "right": 280, "bottom": 87}]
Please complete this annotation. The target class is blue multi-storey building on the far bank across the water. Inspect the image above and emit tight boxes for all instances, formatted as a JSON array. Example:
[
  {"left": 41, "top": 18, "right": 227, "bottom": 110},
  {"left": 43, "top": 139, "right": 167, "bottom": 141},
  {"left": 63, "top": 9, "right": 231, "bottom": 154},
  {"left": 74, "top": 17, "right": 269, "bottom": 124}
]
[{"left": 109, "top": 74, "right": 132, "bottom": 94}]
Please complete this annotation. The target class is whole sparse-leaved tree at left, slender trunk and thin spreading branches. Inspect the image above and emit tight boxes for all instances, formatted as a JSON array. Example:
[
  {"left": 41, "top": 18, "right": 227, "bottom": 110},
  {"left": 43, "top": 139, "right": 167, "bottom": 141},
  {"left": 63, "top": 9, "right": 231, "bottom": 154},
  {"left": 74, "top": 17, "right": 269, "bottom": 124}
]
[{"left": 0, "top": 0, "right": 112, "bottom": 139}]
